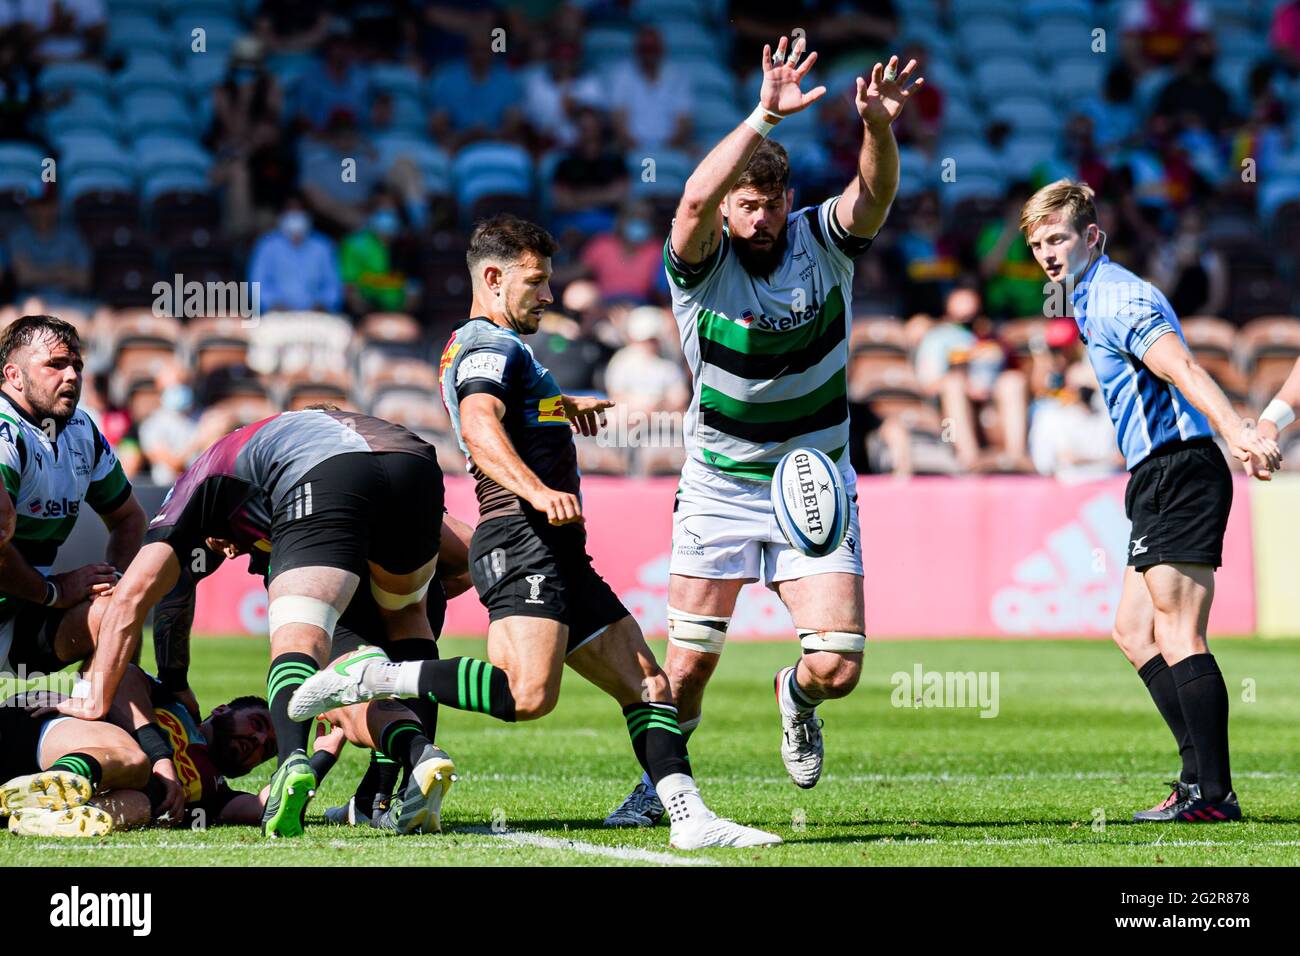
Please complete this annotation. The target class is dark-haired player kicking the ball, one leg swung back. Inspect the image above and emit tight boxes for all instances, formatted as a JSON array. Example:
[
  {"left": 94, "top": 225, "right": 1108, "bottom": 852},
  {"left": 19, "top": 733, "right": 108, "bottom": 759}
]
[{"left": 291, "top": 216, "right": 780, "bottom": 849}]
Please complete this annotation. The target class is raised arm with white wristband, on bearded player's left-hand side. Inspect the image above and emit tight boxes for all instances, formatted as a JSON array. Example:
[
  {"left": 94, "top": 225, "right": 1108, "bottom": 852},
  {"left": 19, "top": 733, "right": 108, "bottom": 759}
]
[{"left": 671, "top": 36, "right": 821, "bottom": 265}]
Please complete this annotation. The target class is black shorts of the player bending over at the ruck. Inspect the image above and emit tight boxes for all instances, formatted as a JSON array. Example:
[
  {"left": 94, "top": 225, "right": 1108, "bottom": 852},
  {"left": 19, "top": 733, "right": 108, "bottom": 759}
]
[{"left": 267, "top": 451, "right": 443, "bottom": 584}]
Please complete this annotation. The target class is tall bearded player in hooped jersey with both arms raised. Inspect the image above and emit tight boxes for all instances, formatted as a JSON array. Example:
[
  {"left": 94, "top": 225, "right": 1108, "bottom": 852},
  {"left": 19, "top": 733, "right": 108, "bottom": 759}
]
[{"left": 606, "top": 36, "right": 923, "bottom": 826}]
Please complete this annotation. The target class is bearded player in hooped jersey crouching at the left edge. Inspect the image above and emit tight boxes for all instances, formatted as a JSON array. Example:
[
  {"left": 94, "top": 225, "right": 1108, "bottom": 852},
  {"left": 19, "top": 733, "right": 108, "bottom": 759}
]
[{"left": 0, "top": 315, "right": 146, "bottom": 676}]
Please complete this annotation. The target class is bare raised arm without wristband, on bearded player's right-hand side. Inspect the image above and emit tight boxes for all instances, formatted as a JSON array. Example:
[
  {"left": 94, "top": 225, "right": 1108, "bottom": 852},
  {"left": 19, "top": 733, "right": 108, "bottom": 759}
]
[{"left": 835, "top": 56, "right": 926, "bottom": 238}]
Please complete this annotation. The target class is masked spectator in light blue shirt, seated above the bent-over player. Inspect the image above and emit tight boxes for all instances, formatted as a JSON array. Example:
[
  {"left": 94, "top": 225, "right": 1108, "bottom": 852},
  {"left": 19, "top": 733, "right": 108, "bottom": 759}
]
[{"left": 248, "top": 196, "right": 343, "bottom": 312}]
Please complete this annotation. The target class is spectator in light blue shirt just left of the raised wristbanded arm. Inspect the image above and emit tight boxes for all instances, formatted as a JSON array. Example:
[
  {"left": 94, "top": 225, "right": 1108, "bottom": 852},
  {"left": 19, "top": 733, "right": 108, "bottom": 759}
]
[{"left": 608, "top": 26, "right": 692, "bottom": 150}]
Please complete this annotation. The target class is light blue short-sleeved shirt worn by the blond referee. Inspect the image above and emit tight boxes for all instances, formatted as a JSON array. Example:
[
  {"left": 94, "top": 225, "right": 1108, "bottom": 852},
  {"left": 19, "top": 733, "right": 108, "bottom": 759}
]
[{"left": 1071, "top": 255, "right": 1214, "bottom": 471}]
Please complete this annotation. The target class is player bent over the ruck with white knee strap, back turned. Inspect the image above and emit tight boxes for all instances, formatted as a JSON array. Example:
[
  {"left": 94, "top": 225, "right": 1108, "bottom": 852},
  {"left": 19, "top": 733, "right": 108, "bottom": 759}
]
[{"left": 60, "top": 410, "right": 457, "bottom": 836}]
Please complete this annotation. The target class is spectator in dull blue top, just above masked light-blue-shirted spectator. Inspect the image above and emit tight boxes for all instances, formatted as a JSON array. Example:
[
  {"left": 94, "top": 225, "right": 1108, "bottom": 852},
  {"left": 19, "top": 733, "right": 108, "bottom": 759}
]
[{"left": 298, "top": 109, "right": 382, "bottom": 237}]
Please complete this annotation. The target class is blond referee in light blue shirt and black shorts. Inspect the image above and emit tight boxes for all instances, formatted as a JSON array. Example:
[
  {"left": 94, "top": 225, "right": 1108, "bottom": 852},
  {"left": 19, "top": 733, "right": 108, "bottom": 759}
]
[{"left": 1021, "top": 179, "right": 1282, "bottom": 822}]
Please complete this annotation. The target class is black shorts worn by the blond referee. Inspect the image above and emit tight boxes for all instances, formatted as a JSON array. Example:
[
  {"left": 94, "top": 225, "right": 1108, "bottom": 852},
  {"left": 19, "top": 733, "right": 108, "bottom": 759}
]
[{"left": 1125, "top": 438, "right": 1232, "bottom": 570}]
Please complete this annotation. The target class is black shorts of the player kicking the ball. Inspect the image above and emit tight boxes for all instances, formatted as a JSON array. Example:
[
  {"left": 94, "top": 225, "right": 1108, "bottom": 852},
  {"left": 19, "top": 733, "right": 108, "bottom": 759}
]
[{"left": 469, "top": 511, "right": 628, "bottom": 653}]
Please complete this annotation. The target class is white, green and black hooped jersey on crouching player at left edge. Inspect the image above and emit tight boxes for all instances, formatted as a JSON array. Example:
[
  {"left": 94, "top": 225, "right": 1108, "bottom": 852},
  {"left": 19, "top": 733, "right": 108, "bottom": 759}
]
[{"left": 0, "top": 393, "right": 131, "bottom": 619}]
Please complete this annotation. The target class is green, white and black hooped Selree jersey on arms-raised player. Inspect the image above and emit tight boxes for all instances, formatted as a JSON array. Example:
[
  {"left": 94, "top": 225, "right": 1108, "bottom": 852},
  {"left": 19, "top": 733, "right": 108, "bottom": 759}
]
[{"left": 664, "top": 196, "right": 871, "bottom": 481}]
